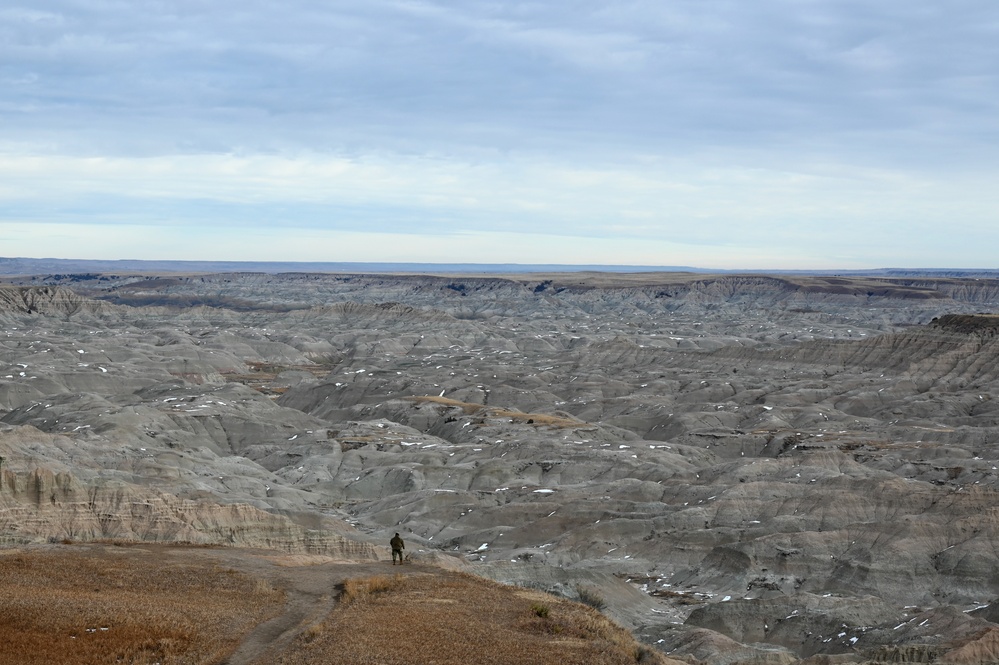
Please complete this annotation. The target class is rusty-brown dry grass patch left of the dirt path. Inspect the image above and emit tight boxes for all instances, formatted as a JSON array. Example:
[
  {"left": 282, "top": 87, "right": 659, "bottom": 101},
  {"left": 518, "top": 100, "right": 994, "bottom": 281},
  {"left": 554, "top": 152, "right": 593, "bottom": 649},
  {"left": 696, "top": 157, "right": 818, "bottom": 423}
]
[{"left": 0, "top": 550, "right": 283, "bottom": 665}]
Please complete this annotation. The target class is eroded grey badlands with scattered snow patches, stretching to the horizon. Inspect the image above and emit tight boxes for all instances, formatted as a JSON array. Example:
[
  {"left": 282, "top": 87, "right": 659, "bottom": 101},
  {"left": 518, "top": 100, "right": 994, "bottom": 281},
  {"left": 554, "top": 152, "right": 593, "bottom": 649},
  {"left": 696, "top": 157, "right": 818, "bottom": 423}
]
[{"left": 0, "top": 273, "right": 999, "bottom": 664}]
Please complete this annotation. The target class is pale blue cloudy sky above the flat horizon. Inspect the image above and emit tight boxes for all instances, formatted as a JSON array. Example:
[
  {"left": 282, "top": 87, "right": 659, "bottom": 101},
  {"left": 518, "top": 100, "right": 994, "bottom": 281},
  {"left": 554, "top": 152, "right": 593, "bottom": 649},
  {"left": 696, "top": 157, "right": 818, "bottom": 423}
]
[{"left": 0, "top": 0, "right": 999, "bottom": 270}]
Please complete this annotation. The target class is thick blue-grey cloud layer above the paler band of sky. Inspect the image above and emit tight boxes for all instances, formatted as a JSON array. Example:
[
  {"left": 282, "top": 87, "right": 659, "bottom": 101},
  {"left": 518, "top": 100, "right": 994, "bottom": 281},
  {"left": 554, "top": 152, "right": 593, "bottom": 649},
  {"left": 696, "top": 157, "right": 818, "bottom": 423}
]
[{"left": 3, "top": 1, "right": 999, "bottom": 159}]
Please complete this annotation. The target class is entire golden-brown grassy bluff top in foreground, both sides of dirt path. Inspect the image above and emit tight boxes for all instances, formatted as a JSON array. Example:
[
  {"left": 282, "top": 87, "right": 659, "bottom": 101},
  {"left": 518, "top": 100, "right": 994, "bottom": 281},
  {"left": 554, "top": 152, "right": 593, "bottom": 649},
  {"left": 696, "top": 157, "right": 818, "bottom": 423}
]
[{"left": 0, "top": 544, "right": 677, "bottom": 665}]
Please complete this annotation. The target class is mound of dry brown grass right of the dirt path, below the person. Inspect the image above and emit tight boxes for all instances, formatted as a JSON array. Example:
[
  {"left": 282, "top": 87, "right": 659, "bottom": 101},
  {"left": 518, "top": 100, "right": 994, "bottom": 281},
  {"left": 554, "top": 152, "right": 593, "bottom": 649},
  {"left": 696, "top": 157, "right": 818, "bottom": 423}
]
[{"left": 281, "top": 573, "right": 673, "bottom": 665}]
